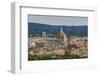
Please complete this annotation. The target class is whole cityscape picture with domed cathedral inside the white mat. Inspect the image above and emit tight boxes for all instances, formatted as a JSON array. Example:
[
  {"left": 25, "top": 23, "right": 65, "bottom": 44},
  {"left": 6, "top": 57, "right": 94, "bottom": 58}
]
[{"left": 28, "top": 15, "right": 88, "bottom": 61}]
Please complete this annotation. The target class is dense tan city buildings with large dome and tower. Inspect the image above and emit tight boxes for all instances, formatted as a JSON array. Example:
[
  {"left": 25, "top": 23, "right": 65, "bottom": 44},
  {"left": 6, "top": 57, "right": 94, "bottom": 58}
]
[{"left": 28, "top": 28, "right": 88, "bottom": 57}]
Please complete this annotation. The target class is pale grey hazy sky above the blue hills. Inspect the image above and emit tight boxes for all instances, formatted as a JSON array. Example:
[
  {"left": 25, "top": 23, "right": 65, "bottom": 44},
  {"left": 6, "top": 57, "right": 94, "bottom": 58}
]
[{"left": 28, "top": 15, "right": 88, "bottom": 26}]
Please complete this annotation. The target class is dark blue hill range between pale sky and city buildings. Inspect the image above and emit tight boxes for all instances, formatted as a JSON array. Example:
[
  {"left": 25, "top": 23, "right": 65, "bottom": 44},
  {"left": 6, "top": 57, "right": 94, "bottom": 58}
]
[{"left": 28, "top": 23, "right": 88, "bottom": 37}]
